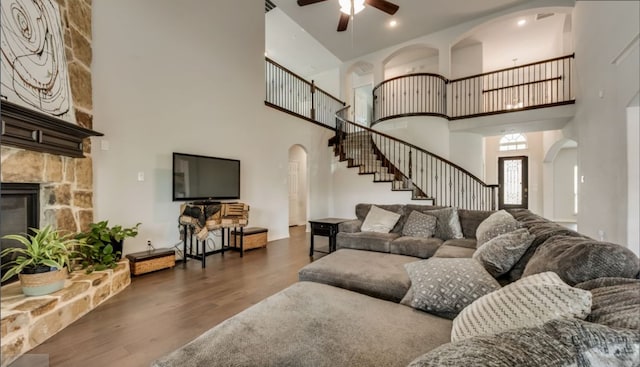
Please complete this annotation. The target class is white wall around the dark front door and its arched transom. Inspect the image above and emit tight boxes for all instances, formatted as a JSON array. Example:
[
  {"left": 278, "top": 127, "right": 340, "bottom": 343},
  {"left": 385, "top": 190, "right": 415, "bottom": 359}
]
[{"left": 485, "top": 132, "right": 544, "bottom": 215}]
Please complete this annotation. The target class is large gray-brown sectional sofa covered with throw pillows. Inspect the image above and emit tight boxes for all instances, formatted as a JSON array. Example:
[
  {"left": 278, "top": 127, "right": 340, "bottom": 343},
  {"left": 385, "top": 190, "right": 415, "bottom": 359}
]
[{"left": 153, "top": 204, "right": 640, "bottom": 367}]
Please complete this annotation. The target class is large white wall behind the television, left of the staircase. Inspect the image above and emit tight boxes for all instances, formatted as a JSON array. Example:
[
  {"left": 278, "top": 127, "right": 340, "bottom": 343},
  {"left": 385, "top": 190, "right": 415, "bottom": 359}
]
[{"left": 92, "top": 0, "right": 331, "bottom": 253}]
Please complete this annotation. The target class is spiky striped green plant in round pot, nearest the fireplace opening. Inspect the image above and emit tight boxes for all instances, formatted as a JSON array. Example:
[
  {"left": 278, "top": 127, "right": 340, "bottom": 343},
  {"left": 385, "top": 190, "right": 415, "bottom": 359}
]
[{"left": 0, "top": 225, "right": 82, "bottom": 296}]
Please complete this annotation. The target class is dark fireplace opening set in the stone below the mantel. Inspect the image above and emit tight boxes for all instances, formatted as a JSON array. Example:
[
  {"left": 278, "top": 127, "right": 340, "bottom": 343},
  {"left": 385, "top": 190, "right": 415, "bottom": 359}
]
[{"left": 0, "top": 182, "right": 40, "bottom": 285}]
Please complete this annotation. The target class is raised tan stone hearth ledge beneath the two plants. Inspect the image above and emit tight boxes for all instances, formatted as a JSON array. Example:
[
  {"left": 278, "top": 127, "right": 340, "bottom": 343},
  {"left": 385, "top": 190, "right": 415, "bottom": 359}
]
[{"left": 0, "top": 258, "right": 131, "bottom": 367}]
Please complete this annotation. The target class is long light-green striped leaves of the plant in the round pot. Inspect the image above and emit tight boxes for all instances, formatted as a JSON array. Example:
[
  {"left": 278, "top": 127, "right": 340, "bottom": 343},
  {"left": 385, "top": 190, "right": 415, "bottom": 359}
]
[{"left": 0, "top": 225, "right": 83, "bottom": 282}]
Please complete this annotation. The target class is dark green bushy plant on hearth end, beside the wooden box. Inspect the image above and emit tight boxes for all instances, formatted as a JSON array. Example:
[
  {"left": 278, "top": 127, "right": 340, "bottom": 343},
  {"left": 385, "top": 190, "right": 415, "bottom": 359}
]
[{"left": 77, "top": 220, "right": 140, "bottom": 273}]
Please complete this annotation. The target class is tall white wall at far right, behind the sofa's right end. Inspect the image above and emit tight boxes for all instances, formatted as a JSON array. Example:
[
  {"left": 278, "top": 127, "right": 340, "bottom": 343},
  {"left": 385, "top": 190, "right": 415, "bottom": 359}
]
[{"left": 573, "top": 1, "right": 640, "bottom": 245}]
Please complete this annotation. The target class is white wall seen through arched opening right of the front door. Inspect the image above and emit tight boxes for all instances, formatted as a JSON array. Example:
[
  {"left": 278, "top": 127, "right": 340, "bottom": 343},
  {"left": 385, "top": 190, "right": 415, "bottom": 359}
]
[{"left": 545, "top": 148, "right": 578, "bottom": 222}]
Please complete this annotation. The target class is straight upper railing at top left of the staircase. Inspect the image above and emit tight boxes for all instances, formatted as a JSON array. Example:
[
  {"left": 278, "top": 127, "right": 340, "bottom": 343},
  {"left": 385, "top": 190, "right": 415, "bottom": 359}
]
[{"left": 265, "top": 58, "right": 345, "bottom": 129}]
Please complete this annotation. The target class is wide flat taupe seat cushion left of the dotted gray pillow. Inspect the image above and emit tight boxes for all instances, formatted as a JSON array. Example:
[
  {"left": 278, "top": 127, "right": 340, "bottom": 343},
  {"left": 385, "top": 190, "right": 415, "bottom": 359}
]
[{"left": 298, "top": 249, "right": 416, "bottom": 302}]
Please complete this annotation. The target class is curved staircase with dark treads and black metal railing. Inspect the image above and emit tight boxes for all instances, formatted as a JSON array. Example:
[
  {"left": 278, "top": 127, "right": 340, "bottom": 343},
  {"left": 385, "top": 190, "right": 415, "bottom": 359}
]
[{"left": 329, "top": 106, "right": 498, "bottom": 210}]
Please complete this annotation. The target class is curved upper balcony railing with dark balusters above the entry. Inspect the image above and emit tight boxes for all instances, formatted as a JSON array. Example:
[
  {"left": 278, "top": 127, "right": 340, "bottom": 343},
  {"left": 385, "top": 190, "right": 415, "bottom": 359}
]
[{"left": 373, "top": 55, "right": 575, "bottom": 124}]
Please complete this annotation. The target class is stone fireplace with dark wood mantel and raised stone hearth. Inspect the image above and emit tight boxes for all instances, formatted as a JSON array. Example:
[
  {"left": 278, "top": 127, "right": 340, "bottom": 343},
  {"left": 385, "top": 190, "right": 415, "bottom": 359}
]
[{"left": 0, "top": 0, "right": 131, "bottom": 367}]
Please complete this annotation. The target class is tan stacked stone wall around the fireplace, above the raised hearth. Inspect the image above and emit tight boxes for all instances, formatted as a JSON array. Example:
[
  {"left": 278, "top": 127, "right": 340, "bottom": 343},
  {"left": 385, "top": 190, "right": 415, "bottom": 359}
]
[{"left": 0, "top": 0, "right": 93, "bottom": 232}]
